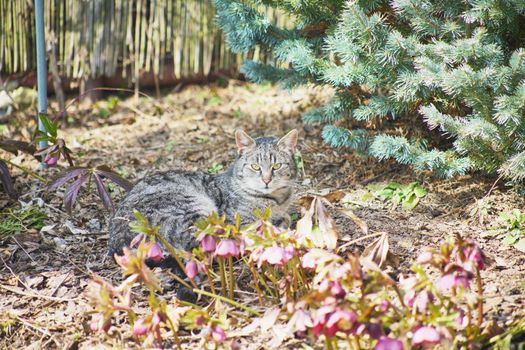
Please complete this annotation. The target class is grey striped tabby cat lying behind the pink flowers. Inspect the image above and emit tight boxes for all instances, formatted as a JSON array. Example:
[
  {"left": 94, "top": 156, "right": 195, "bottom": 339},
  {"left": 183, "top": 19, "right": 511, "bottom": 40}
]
[{"left": 109, "top": 129, "right": 298, "bottom": 255}]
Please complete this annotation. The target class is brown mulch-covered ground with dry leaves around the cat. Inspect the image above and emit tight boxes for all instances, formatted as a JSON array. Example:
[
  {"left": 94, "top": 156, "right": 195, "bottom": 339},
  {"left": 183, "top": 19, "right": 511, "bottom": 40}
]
[{"left": 0, "top": 81, "right": 525, "bottom": 349}]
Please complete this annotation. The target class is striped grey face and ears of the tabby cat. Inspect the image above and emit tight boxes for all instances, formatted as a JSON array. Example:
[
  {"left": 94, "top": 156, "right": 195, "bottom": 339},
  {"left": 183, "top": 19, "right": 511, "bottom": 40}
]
[{"left": 231, "top": 129, "right": 298, "bottom": 194}]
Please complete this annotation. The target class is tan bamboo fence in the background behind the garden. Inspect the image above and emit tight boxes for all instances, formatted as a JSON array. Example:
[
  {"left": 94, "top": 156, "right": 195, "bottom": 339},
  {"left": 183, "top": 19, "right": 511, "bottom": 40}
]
[{"left": 0, "top": 0, "right": 286, "bottom": 81}]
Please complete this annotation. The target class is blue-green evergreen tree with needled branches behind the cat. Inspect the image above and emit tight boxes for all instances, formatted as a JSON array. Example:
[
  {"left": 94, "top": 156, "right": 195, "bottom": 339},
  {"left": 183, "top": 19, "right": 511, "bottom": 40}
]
[{"left": 215, "top": 0, "right": 525, "bottom": 180}]
